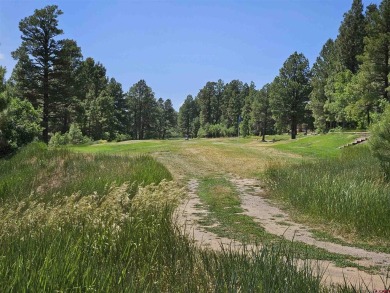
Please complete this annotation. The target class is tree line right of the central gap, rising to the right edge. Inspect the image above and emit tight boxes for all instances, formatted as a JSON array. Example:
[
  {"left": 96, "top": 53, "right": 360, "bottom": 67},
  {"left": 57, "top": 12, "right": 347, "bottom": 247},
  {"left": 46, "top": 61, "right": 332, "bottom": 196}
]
[{"left": 179, "top": 0, "right": 390, "bottom": 139}]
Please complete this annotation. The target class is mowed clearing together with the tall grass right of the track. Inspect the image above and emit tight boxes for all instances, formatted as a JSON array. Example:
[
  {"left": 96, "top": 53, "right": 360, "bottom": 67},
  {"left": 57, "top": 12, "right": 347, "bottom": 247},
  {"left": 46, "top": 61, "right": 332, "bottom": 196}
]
[{"left": 72, "top": 133, "right": 390, "bottom": 244}]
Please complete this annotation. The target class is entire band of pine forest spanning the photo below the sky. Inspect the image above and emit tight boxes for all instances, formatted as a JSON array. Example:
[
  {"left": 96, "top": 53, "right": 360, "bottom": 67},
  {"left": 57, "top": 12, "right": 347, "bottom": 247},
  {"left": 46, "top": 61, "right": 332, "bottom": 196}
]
[{"left": 0, "top": 0, "right": 390, "bottom": 154}]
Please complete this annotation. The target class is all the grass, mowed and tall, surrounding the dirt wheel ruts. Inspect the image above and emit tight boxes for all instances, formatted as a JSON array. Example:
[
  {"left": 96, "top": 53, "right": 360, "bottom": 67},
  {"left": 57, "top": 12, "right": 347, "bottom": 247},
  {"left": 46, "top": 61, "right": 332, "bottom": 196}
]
[{"left": 0, "top": 134, "right": 390, "bottom": 292}]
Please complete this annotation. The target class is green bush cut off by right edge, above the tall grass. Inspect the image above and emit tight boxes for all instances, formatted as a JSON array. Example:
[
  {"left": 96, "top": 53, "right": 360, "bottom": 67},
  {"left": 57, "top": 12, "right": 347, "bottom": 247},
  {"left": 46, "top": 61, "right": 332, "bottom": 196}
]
[{"left": 370, "top": 107, "right": 390, "bottom": 180}]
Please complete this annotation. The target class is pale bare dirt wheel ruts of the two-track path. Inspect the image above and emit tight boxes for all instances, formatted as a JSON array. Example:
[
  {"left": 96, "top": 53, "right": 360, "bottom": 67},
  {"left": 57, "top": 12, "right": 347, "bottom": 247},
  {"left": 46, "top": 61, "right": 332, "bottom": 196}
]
[{"left": 176, "top": 178, "right": 390, "bottom": 290}]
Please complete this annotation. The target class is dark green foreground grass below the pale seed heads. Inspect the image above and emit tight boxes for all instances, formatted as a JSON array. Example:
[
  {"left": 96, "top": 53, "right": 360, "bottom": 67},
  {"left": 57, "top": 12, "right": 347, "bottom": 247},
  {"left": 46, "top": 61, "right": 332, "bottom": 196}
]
[{"left": 0, "top": 205, "right": 328, "bottom": 292}]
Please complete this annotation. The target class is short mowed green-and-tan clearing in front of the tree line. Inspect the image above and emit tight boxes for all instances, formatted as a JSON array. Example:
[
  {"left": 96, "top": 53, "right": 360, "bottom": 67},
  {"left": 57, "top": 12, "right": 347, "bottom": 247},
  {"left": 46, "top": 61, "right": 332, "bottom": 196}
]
[{"left": 72, "top": 134, "right": 357, "bottom": 179}]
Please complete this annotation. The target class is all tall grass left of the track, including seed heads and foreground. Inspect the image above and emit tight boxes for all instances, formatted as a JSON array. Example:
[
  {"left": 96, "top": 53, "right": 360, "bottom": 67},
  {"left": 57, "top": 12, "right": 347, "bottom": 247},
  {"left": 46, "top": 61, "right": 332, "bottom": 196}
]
[{"left": 0, "top": 144, "right": 329, "bottom": 292}]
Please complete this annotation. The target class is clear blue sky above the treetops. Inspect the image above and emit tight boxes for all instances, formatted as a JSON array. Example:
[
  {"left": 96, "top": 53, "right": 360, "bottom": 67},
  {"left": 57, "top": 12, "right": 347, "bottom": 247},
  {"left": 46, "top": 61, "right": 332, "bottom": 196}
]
[{"left": 0, "top": 0, "right": 380, "bottom": 109}]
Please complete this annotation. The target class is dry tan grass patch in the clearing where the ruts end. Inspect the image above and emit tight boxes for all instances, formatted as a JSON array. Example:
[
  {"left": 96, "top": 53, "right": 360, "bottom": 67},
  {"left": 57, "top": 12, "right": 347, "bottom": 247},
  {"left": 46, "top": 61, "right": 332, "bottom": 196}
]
[{"left": 154, "top": 140, "right": 292, "bottom": 179}]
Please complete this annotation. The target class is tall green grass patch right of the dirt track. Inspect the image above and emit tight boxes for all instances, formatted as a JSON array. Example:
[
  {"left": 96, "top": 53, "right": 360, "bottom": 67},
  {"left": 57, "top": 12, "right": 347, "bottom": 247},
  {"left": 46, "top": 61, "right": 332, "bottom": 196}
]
[{"left": 266, "top": 146, "right": 390, "bottom": 240}]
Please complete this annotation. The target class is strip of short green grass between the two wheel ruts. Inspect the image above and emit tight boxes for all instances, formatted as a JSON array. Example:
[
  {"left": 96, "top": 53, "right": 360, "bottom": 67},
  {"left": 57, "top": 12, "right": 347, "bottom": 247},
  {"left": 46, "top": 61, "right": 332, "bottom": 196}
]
[{"left": 198, "top": 178, "right": 364, "bottom": 271}]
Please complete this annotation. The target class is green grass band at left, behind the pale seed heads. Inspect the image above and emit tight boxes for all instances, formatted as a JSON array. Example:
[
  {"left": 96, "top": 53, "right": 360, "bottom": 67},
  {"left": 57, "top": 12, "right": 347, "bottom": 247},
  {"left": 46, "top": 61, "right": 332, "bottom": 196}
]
[{"left": 0, "top": 143, "right": 172, "bottom": 200}]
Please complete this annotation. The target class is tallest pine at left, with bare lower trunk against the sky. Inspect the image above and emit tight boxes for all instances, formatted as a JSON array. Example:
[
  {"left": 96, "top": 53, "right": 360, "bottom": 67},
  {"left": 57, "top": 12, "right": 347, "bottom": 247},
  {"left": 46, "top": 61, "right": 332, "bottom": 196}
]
[{"left": 12, "top": 5, "right": 63, "bottom": 143}]
